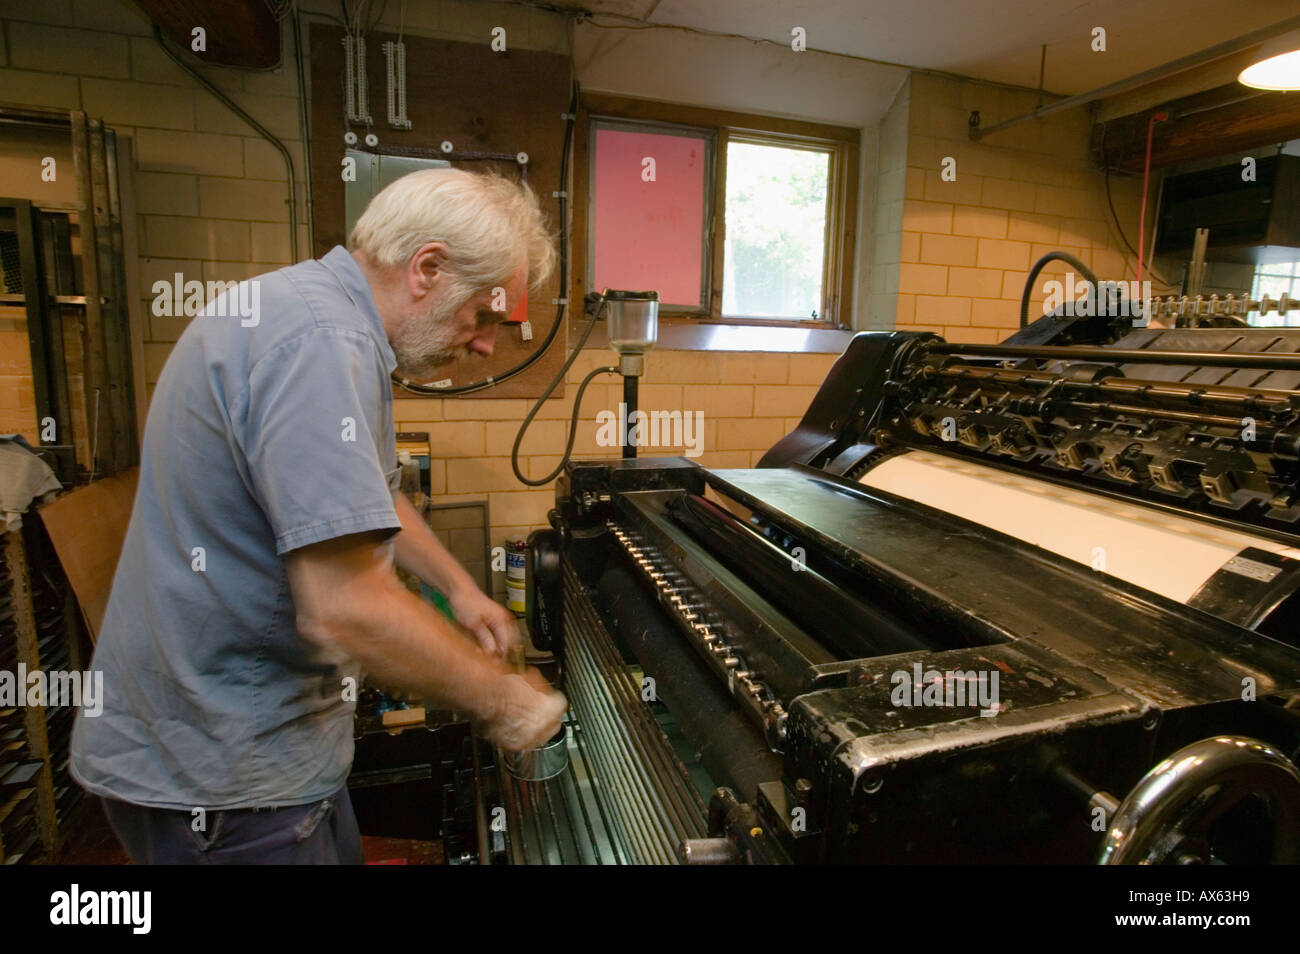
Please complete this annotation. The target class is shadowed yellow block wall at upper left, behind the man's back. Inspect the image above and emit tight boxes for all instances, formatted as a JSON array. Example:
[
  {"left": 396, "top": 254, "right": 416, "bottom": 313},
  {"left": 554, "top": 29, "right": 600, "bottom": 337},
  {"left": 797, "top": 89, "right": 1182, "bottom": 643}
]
[{"left": 0, "top": 0, "right": 311, "bottom": 405}]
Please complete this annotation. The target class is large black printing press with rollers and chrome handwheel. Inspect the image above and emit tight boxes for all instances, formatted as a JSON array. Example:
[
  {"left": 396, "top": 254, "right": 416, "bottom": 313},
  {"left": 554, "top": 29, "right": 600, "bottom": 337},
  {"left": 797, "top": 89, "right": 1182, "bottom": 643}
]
[{"left": 452, "top": 306, "right": 1300, "bottom": 863}]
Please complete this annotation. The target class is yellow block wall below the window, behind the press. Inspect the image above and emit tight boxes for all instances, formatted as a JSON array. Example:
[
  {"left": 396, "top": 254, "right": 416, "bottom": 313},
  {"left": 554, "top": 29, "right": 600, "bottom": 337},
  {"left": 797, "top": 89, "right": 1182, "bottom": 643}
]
[{"left": 393, "top": 348, "right": 837, "bottom": 595}]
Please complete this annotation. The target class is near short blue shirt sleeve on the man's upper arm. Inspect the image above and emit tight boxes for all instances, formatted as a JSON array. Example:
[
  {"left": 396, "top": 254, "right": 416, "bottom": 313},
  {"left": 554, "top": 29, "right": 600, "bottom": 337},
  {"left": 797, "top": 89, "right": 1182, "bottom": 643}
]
[{"left": 239, "top": 328, "right": 402, "bottom": 554}]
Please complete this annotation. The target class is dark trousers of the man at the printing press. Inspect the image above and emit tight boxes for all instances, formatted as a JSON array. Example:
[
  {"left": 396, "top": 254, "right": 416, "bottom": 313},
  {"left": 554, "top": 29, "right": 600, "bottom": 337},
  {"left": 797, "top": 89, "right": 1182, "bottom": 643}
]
[{"left": 103, "top": 785, "right": 364, "bottom": 864}]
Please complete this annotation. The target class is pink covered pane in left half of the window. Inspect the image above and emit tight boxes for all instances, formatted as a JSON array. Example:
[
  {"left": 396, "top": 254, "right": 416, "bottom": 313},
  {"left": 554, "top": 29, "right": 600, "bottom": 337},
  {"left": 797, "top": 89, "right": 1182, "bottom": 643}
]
[{"left": 592, "top": 129, "right": 707, "bottom": 305}]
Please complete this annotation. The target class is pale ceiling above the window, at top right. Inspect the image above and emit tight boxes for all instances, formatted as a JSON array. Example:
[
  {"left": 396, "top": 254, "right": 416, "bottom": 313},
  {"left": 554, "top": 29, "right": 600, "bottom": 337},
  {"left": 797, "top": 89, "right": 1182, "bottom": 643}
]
[{"left": 553, "top": 0, "right": 1297, "bottom": 94}]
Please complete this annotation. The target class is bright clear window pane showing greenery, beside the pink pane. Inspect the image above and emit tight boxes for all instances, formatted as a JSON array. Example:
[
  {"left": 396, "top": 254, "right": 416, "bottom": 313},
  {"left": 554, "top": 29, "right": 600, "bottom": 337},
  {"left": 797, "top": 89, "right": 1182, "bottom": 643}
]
[{"left": 723, "top": 139, "right": 831, "bottom": 320}]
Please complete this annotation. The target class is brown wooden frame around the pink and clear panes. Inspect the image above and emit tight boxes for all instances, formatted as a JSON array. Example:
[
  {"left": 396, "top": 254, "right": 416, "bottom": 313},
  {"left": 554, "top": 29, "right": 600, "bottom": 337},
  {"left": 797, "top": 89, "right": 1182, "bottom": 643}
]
[{"left": 569, "top": 92, "right": 862, "bottom": 329}]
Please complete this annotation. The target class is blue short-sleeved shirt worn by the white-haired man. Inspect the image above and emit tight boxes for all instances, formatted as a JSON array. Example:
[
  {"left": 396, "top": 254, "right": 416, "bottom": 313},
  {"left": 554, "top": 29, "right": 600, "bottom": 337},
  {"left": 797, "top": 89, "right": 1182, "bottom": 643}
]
[{"left": 70, "top": 247, "right": 400, "bottom": 810}]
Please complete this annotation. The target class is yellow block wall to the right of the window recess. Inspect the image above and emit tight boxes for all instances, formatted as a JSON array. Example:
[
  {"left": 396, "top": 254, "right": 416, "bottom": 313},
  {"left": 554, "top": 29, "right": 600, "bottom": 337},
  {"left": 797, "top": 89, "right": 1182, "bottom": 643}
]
[{"left": 876, "top": 73, "right": 1166, "bottom": 343}]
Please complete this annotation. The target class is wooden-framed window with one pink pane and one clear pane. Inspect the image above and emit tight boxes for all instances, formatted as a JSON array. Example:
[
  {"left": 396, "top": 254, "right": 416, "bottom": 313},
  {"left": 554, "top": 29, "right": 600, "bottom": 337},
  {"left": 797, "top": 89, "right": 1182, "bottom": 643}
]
[{"left": 585, "top": 94, "right": 861, "bottom": 325}]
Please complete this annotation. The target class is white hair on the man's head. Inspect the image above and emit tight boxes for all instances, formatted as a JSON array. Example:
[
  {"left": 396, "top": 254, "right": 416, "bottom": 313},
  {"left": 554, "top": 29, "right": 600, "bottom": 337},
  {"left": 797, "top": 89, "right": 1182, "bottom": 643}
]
[{"left": 348, "top": 169, "right": 564, "bottom": 299}]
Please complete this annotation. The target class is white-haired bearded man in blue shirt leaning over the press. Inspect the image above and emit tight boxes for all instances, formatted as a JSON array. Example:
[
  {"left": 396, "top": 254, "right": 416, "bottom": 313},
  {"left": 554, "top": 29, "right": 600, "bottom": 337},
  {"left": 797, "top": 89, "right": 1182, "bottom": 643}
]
[{"left": 72, "top": 169, "right": 566, "bottom": 863}]
